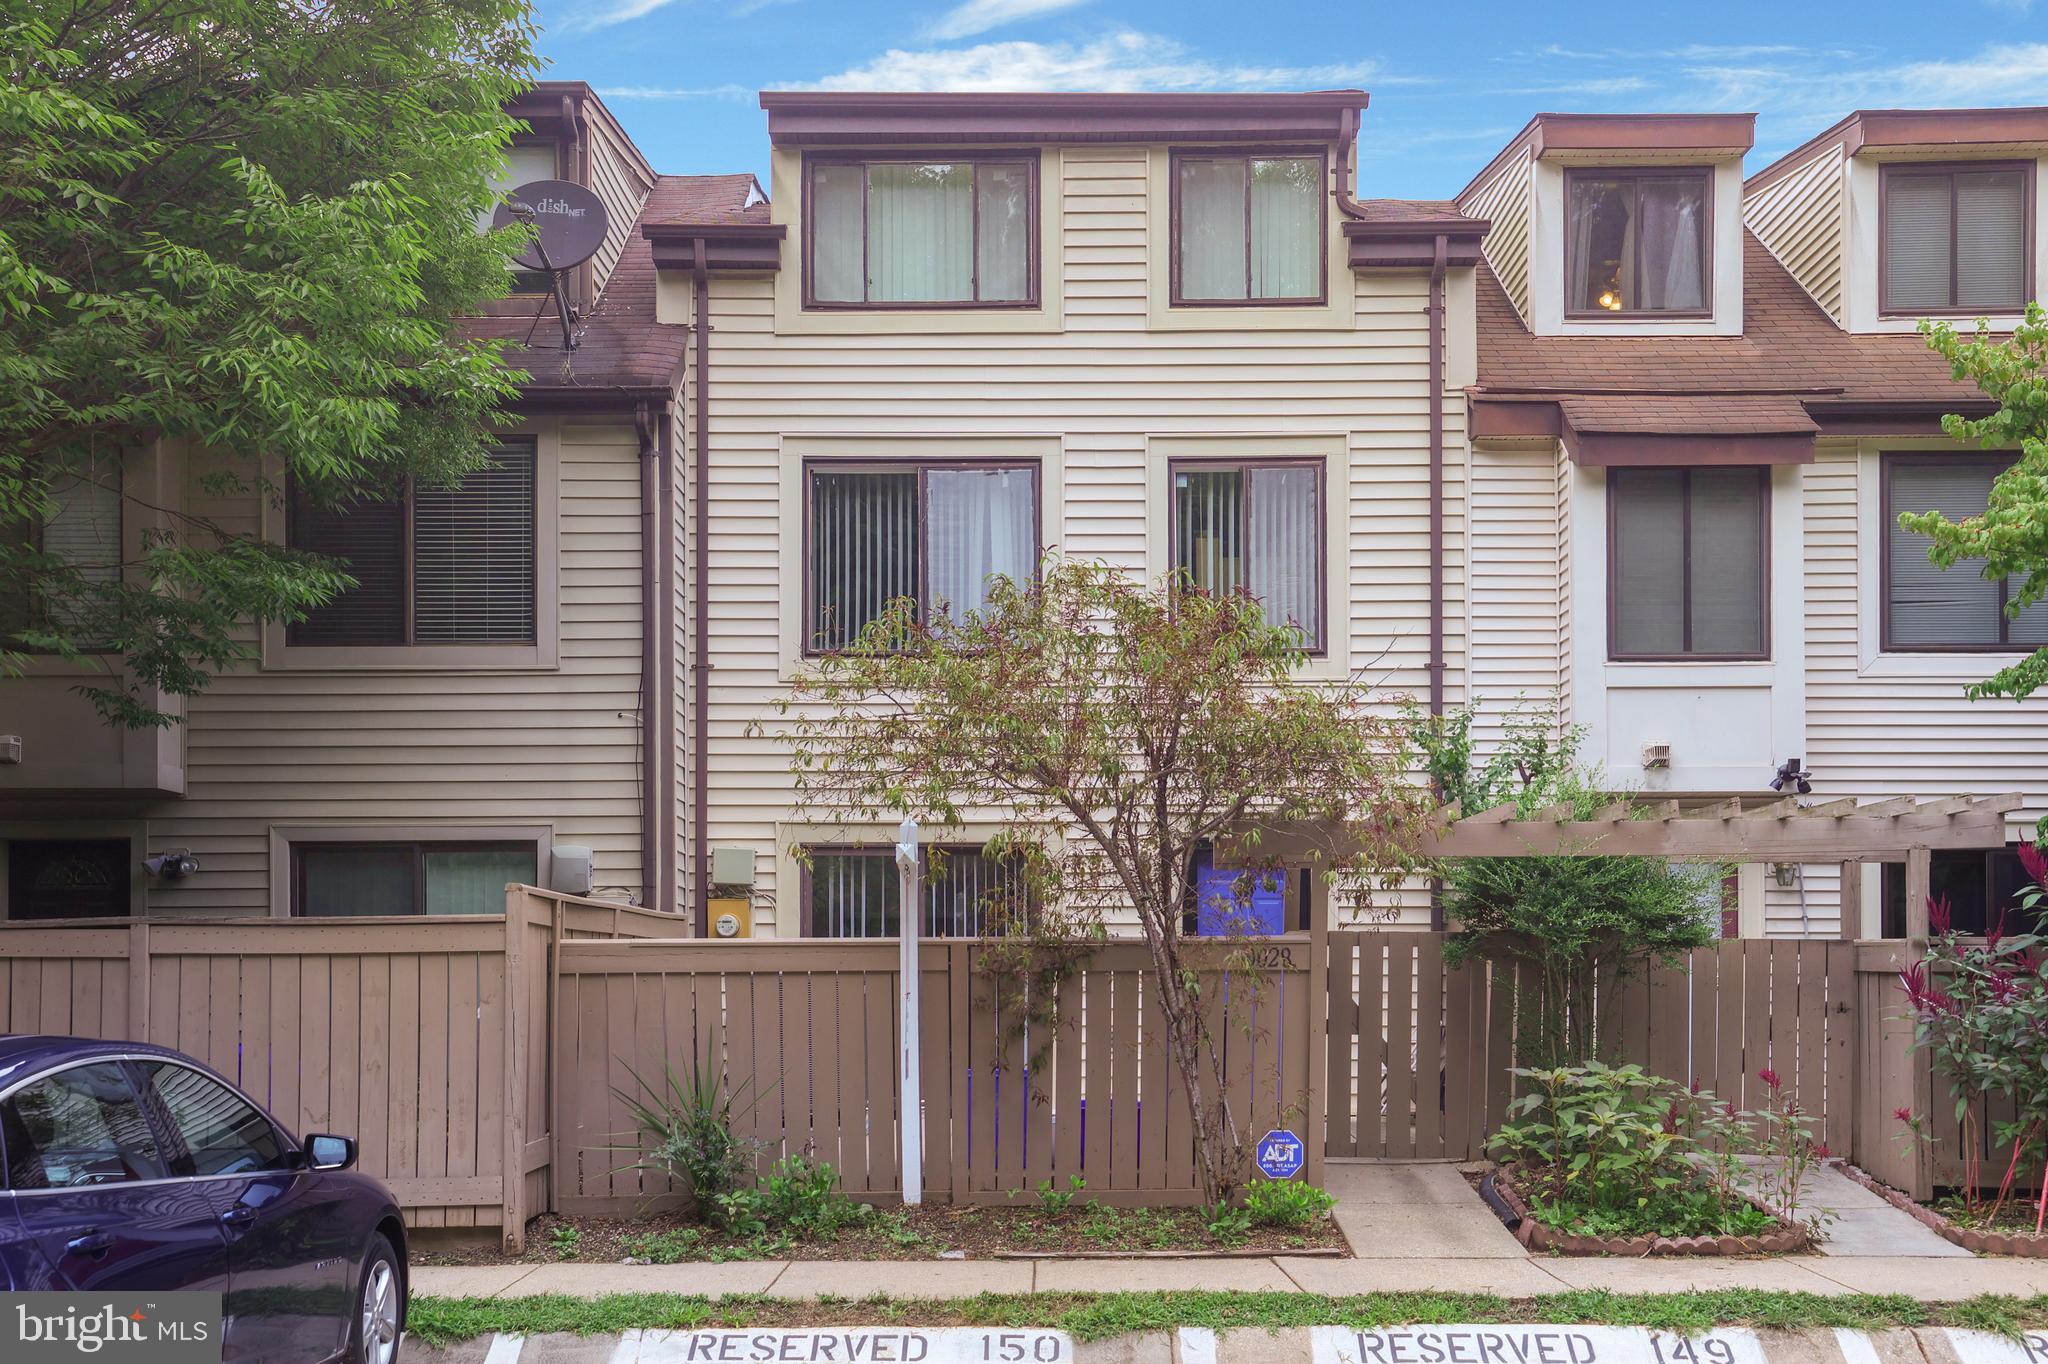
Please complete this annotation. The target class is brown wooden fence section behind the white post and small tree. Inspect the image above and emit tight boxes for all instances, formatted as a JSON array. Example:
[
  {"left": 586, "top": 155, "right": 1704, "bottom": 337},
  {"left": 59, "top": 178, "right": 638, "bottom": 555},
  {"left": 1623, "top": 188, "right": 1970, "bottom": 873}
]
[{"left": 555, "top": 936, "right": 1321, "bottom": 1212}]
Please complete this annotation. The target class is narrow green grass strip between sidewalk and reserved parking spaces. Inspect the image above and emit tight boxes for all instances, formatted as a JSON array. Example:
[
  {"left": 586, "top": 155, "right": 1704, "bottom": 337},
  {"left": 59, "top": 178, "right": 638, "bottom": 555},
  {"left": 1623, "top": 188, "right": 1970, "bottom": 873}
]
[{"left": 408, "top": 1288, "right": 2048, "bottom": 1346}]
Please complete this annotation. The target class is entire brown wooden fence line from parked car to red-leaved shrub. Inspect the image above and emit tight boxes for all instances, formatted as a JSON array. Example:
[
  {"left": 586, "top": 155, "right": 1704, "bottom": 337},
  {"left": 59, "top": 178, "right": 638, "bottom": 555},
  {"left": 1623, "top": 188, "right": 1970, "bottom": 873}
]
[{"left": 0, "top": 887, "right": 1989, "bottom": 1245}]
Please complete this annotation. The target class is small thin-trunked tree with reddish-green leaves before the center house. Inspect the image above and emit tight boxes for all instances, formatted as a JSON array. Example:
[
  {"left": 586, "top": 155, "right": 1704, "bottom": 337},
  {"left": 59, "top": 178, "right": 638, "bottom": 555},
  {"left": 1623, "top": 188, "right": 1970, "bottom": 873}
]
[{"left": 782, "top": 559, "right": 1425, "bottom": 1200}]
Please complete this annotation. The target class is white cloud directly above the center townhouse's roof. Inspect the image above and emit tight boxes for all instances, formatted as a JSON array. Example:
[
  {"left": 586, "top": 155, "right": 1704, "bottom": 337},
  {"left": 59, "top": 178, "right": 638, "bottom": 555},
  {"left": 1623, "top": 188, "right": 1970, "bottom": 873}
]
[{"left": 784, "top": 29, "right": 1384, "bottom": 92}]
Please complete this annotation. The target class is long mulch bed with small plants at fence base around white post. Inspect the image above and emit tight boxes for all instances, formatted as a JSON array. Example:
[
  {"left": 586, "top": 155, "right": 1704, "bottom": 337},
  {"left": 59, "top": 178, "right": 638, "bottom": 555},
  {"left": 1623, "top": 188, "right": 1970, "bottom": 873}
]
[{"left": 414, "top": 1204, "right": 1350, "bottom": 1264}]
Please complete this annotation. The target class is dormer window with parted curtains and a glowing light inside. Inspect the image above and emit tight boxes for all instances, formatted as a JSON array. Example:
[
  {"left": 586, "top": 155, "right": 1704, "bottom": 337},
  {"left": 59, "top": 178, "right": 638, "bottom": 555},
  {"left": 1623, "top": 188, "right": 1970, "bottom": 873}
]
[{"left": 1565, "top": 166, "right": 1712, "bottom": 317}]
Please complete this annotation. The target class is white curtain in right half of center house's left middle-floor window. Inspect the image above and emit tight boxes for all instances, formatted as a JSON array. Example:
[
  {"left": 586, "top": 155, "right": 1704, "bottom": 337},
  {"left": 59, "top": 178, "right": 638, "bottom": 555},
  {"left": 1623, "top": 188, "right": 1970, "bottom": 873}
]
[{"left": 926, "top": 469, "right": 1038, "bottom": 621}]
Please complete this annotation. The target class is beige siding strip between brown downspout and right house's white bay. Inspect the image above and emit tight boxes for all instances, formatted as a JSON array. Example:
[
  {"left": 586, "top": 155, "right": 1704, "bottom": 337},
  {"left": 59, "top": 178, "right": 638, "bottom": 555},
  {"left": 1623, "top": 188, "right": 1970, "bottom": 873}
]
[{"left": 1473, "top": 444, "right": 1569, "bottom": 745}]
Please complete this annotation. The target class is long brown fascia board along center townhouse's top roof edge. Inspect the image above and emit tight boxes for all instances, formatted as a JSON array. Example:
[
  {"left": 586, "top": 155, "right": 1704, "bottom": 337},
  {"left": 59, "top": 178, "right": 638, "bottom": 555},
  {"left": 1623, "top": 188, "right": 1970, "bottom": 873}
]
[{"left": 760, "top": 90, "right": 1368, "bottom": 147}]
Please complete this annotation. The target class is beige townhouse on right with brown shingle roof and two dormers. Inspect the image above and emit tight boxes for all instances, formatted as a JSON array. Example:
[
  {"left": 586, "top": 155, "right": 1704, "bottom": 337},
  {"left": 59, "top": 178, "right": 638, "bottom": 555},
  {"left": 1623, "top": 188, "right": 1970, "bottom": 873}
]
[{"left": 1458, "top": 109, "right": 2048, "bottom": 938}]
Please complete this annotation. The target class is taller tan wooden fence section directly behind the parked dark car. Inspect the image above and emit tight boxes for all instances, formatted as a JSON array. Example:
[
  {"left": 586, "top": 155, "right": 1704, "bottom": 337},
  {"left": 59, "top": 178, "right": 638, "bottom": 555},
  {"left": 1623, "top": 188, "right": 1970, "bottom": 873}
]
[{"left": 0, "top": 889, "right": 674, "bottom": 1241}]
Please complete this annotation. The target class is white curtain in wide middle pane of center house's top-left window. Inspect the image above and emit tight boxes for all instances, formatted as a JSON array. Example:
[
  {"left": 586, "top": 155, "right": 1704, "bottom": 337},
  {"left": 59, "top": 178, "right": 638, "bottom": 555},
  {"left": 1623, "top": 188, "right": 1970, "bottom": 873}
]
[{"left": 868, "top": 162, "right": 975, "bottom": 303}]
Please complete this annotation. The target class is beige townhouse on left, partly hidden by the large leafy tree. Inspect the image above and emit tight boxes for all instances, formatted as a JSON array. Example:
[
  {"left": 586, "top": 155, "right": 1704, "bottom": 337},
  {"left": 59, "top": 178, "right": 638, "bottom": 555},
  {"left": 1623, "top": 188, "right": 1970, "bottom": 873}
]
[{"left": 0, "top": 82, "right": 760, "bottom": 920}]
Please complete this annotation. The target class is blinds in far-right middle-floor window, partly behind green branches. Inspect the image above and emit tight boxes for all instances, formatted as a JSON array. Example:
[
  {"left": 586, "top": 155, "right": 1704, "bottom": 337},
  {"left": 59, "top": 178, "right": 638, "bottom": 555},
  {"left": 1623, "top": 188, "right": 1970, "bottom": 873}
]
[{"left": 1884, "top": 459, "right": 2048, "bottom": 649}]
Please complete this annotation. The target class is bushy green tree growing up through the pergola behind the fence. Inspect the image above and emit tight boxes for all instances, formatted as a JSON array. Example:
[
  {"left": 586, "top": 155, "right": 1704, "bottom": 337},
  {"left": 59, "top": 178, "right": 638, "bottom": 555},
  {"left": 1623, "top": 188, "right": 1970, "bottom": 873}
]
[{"left": 1417, "top": 707, "right": 1726, "bottom": 1067}]
